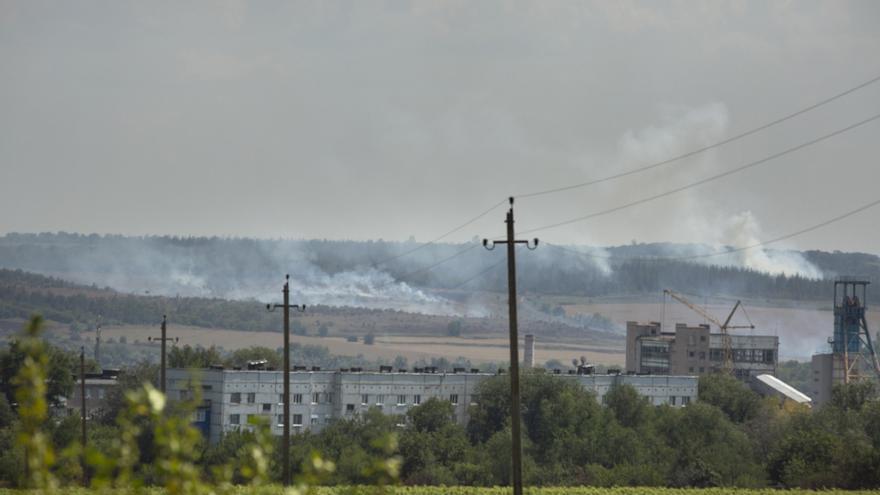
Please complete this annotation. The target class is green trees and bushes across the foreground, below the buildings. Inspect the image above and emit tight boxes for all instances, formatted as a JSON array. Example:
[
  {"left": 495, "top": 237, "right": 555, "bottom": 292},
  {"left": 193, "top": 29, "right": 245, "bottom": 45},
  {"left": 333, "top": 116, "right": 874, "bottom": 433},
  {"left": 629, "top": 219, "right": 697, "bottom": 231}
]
[{"left": 0, "top": 317, "right": 880, "bottom": 495}]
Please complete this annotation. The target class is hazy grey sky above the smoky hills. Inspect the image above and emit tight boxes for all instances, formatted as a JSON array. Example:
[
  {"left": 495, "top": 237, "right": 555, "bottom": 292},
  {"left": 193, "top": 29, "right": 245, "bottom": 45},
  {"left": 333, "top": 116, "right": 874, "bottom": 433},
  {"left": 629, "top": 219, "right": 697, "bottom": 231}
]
[{"left": 0, "top": 0, "right": 880, "bottom": 253}]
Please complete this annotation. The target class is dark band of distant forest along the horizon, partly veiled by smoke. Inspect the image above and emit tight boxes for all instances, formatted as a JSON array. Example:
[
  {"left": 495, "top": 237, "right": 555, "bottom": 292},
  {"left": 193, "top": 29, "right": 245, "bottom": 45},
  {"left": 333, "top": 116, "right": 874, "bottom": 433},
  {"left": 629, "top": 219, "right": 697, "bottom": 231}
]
[{"left": 0, "top": 233, "right": 880, "bottom": 300}]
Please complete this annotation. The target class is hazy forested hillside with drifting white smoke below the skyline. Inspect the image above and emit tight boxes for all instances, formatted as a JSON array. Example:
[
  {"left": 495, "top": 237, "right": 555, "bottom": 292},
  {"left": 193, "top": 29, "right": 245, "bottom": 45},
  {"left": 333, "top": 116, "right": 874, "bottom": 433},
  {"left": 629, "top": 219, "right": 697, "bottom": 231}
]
[{"left": 0, "top": 233, "right": 880, "bottom": 307}]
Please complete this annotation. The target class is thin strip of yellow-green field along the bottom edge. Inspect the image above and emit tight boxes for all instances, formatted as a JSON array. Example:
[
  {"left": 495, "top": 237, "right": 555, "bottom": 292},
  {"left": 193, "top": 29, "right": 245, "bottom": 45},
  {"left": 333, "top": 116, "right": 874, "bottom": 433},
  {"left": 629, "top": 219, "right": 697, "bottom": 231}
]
[{"left": 0, "top": 485, "right": 877, "bottom": 495}]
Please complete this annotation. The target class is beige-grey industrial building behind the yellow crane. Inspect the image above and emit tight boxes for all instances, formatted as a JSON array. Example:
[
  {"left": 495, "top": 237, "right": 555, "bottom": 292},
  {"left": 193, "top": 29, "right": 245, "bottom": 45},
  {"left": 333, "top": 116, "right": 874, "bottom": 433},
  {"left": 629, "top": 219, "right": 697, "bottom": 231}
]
[{"left": 626, "top": 321, "right": 779, "bottom": 381}]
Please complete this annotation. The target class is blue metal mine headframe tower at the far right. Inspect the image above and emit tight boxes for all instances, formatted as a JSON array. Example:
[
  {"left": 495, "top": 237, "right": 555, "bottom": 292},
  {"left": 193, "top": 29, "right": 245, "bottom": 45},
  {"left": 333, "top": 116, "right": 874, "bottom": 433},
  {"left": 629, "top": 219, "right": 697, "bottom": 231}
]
[{"left": 828, "top": 277, "right": 880, "bottom": 383}]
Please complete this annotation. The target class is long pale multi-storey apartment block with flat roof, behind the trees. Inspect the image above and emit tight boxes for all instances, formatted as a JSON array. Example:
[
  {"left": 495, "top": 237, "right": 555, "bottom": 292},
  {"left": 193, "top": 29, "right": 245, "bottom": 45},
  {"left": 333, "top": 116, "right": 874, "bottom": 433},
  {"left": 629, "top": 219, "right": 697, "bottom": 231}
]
[{"left": 168, "top": 368, "right": 697, "bottom": 442}]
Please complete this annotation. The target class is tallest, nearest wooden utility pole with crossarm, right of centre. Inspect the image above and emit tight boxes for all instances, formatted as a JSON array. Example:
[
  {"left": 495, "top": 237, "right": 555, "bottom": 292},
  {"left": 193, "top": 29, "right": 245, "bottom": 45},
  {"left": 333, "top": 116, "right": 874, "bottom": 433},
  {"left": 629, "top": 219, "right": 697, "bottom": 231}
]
[{"left": 483, "top": 196, "right": 538, "bottom": 495}]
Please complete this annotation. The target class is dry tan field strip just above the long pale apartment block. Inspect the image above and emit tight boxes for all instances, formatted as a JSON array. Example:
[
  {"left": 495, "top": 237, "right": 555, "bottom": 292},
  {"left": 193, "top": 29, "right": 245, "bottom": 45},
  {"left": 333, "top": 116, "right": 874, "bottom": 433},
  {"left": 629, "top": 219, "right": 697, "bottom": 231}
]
[{"left": 83, "top": 325, "right": 624, "bottom": 365}]
